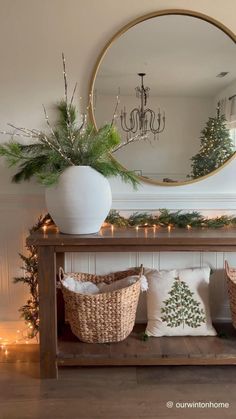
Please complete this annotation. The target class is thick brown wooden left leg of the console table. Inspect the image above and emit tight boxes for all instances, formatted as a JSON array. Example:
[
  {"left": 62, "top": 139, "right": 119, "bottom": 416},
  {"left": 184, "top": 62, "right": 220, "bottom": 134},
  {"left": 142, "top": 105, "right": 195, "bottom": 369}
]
[{"left": 38, "top": 246, "right": 58, "bottom": 378}]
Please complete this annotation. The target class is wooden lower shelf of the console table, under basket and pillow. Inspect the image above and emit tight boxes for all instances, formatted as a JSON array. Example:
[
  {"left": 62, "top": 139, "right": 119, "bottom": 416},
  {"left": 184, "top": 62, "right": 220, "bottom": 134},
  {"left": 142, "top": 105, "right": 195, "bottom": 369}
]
[{"left": 57, "top": 323, "right": 236, "bottom": 366}]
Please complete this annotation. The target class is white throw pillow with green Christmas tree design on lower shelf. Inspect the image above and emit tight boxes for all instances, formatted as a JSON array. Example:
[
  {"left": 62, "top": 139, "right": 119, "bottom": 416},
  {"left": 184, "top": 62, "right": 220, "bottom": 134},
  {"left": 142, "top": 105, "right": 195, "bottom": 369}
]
[{"left": 144, "top": 267, "right": 216, "bottom": 337}]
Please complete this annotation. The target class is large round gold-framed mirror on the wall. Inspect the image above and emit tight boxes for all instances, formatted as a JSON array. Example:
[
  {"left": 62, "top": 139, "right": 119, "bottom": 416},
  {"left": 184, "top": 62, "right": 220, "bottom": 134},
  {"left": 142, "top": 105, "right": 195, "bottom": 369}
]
[{"left": 90, "top": 10, "right": 236, "bottom": 186}]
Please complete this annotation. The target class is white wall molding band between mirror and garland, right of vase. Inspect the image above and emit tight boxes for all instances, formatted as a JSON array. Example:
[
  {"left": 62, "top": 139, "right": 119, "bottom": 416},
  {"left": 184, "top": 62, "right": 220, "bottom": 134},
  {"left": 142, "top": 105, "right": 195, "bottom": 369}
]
[{"left": 112, "top": 193, "right": 236, "bottom": 213}]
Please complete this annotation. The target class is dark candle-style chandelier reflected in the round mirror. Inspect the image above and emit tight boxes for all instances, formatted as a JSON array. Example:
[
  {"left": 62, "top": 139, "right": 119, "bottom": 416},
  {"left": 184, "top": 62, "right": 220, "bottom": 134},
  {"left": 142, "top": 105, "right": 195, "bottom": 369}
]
[{"left": 120, "top": 73, "right": 166, "bottom": 139}]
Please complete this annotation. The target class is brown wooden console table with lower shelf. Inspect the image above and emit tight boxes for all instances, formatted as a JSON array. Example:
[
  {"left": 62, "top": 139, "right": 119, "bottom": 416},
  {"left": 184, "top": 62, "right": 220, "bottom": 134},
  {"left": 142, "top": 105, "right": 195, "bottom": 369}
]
[{"left": 27, "top": 227, "right": 236, "bottom": 378}]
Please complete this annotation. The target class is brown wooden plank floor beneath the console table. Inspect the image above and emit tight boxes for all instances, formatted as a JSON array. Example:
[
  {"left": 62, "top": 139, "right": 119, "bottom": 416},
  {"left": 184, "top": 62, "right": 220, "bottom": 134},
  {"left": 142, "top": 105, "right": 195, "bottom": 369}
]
[{"left": 0, "top": 338, "right": 236, "bottom": 419}]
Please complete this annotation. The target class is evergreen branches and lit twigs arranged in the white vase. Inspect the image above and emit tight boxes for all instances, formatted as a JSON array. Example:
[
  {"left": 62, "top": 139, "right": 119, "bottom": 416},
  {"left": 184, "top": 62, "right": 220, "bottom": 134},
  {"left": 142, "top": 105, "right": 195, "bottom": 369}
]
[{"left": 0, "top": 55, "right": 138, "bottom": 187}]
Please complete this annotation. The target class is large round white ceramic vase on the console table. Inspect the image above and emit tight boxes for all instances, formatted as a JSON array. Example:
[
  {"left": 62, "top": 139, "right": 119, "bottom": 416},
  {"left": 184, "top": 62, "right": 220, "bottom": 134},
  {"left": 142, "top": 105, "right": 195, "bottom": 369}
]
[{"left": 46, "top": 166, "right": 112, "bottom": 234}]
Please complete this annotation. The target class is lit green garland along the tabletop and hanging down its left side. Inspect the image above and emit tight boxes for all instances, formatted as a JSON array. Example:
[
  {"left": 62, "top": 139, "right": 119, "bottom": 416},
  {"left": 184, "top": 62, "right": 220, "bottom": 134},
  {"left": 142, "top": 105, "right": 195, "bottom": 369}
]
[{"left": 14, "top": 209, "right": 236, "bottom": 340}]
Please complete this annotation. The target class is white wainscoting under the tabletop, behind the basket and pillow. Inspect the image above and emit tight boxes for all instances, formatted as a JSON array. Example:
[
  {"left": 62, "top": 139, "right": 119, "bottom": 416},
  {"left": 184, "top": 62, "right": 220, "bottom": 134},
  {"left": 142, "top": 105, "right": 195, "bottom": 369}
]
[{"left": 66, "top": 252, "right": 236, "bottom": 323}]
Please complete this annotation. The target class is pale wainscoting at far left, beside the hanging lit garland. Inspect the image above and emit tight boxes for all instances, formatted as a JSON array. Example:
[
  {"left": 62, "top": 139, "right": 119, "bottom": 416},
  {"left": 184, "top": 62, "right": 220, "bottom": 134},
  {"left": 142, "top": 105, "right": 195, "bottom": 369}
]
[{"left": 0, "top": 194, "right": 45, "bottom": 322}]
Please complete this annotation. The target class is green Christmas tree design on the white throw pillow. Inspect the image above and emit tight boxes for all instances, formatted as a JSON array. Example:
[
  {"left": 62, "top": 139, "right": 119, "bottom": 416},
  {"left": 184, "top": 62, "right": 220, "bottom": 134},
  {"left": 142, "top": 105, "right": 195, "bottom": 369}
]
[{"left": 161, "top": 278, "right": 206, "bottom": 328}]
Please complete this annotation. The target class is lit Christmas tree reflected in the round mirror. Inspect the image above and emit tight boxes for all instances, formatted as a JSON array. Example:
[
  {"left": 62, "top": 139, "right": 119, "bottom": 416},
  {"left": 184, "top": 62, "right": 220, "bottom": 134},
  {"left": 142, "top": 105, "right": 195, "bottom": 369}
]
[{"left": 188, "top": 106, "right": 234, "bottom": 179}]
